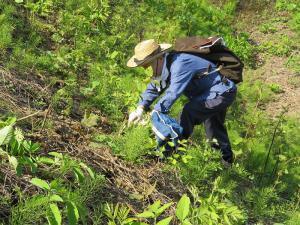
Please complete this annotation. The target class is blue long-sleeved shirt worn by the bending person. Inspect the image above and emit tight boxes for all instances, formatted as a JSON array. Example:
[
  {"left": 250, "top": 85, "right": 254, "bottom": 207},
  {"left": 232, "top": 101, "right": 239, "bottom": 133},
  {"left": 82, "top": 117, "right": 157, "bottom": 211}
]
[{"left": 139, "top": 53, "right": 236, "bottom": 113}]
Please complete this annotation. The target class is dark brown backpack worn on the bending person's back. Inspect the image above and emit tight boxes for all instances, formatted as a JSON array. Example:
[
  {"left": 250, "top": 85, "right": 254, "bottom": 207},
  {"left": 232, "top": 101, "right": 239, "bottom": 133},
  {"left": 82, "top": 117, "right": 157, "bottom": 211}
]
[{"left": 174, "top": 37, "right": 244, "bottom": 84}]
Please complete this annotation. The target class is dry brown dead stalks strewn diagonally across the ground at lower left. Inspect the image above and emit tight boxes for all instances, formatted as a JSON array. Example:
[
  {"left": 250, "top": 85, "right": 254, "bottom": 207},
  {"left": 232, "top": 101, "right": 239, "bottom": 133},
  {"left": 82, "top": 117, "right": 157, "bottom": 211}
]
[{"left": 0, "top": 67, "right": 186, "bottom": 221}]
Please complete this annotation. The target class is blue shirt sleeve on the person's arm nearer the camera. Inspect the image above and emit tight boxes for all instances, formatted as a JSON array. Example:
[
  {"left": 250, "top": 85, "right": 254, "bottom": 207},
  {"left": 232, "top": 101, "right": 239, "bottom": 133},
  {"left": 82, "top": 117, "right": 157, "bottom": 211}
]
[{"left": 154, "top": 62, "right": 194, "bottom": 113}]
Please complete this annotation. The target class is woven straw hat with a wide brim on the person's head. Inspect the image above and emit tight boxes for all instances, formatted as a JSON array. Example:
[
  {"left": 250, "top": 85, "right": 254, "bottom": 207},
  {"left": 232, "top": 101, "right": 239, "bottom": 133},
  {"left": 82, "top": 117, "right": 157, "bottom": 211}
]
[{"left": 127, "top": 39, "right": 172, "bottom": 67}]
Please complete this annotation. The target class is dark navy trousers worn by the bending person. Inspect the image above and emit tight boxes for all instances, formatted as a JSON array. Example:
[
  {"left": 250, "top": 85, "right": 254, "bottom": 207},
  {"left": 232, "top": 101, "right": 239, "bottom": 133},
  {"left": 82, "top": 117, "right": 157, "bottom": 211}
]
[{"left": 180, "top": 90, "right": 236, "bottom": 162}]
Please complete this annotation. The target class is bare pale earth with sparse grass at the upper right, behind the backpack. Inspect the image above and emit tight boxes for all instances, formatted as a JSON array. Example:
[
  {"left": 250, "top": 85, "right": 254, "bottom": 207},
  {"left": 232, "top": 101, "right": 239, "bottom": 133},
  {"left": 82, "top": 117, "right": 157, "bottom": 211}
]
[{"left": 236, "top": 1, "right": 300, "bottom": 117}]
